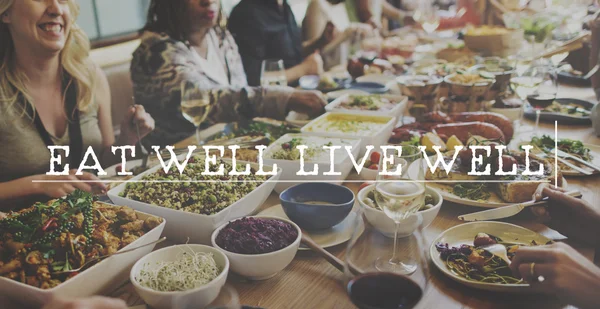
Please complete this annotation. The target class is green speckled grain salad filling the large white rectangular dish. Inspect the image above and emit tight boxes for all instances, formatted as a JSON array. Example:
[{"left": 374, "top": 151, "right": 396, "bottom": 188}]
[{"left": 119, "top": 155, "right": 268, "bottom": 215}]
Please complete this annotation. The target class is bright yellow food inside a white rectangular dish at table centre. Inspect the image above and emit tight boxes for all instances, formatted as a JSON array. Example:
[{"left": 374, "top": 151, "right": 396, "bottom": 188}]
[{"left": 304, "top": 114, "right": 390, "bottom": 136}]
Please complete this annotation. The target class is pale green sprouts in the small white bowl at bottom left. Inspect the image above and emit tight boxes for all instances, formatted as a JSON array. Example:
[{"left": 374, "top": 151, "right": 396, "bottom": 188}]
[{"left": 135, "top": 245, "right": 223, "bottom": 292}]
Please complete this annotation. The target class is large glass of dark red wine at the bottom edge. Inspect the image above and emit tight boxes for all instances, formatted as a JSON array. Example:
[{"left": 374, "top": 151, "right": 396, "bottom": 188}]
[{"left": 343, "top": 196, "right": 430, "bottom": 309}]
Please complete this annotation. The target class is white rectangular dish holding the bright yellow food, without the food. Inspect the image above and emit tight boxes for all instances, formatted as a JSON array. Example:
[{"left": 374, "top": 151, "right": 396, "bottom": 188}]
[{"left": 301, "top": 112, "right": 396, "bottom": 156}]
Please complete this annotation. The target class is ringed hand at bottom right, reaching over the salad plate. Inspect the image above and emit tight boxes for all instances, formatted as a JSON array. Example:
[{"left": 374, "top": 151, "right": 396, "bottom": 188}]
[{"left": 510, "top": 243, "right": 600, "bottom": 308}]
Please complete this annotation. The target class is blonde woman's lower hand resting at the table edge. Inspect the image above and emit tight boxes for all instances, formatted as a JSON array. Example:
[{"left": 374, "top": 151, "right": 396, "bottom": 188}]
[{"left": 32, "top": 170, "right": 106, "bottom": 198}]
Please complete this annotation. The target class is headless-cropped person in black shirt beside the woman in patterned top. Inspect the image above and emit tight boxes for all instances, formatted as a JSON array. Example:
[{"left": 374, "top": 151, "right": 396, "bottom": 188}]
[{"left": 228, "top": 0, "right": 334, "bottom": 86}]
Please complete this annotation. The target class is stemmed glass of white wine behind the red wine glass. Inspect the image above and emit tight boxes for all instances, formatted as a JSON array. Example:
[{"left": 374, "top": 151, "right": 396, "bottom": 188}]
[{"left": 374, "top": 146, "right": 425, "bottom": 275}]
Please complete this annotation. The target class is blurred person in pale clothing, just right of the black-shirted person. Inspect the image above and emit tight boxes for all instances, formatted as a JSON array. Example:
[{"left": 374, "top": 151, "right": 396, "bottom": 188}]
[{"left": 302, "top": 0, "right": 378, "bottom": 70}]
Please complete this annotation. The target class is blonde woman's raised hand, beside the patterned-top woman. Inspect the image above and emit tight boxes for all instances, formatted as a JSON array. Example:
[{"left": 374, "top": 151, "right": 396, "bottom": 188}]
[{"left": 121, "top": 104, "right": 154, "bottom": 145}]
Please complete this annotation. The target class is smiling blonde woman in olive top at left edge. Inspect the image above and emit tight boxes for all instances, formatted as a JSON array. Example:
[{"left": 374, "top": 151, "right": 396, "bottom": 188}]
[{"left": 0, "top": 0, "right": 154, "bottom": 210}]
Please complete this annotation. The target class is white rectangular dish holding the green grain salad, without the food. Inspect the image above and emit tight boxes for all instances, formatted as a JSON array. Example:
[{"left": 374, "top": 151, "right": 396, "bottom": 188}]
[{"left": 108, "top": 159, "right": 281, "bottom": 244}]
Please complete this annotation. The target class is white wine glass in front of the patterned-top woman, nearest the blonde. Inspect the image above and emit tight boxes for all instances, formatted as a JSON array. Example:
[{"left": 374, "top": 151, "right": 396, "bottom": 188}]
[{"left": 181, "top": 80, "right": 216, "bottom": 143}]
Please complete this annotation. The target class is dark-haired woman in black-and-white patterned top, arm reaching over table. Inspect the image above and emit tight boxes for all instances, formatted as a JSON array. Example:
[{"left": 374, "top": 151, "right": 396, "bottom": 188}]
[{"left": 131, "top": 0, "right": 326, "bottom": 145}]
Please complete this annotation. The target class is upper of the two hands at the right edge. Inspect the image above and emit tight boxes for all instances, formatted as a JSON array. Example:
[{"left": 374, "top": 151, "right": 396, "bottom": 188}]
[{"left": 531, "top": 184, "right": 600, "bottom": 246}]
